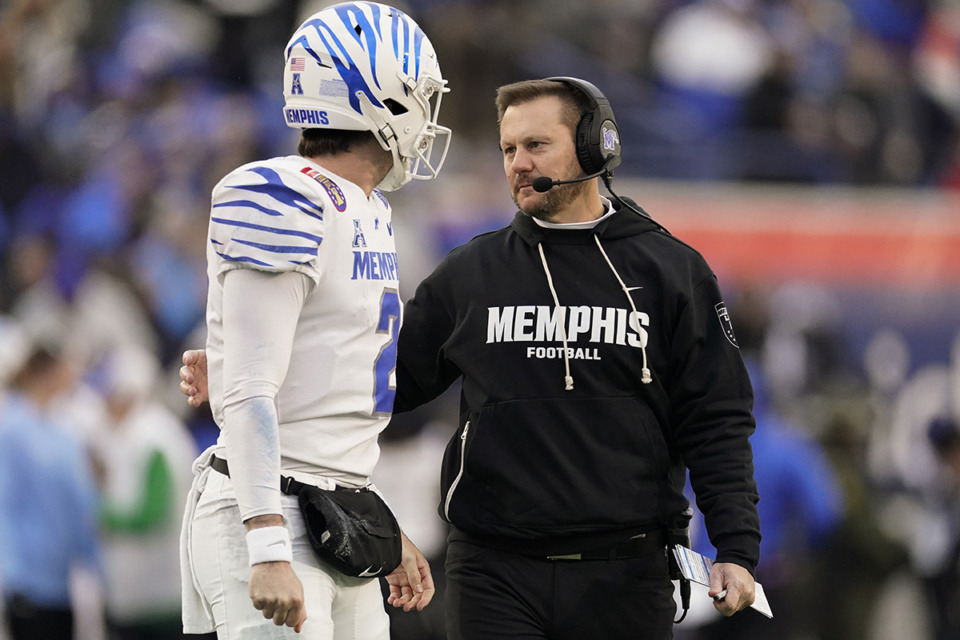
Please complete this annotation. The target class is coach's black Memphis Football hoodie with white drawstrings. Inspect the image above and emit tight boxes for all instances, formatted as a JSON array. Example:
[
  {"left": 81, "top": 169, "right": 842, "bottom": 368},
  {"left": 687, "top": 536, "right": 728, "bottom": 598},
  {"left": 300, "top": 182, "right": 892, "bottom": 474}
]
[{"left": 395, "top": 202, "right": 760, "bottom": 572}]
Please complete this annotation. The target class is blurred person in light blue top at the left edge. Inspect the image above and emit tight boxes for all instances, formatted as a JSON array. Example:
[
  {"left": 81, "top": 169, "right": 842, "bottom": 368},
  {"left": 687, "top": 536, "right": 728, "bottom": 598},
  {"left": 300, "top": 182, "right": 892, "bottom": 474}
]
[{"left": 0, "top": 344, "right": 101, "bottom": 640}]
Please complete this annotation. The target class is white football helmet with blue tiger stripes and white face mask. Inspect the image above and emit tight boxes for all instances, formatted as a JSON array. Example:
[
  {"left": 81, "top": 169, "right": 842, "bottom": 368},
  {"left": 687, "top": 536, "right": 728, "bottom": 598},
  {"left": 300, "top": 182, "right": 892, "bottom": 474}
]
[{"left": 283, "top": 2, "right": 450, "bottom": 191}]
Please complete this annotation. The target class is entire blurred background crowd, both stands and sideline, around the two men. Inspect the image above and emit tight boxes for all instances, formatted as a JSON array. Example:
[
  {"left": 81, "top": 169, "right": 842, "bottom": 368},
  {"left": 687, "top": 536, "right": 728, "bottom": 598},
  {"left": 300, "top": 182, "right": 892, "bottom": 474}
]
[{"left": 0, "top": 0, "right": 960, "bottom": 640}]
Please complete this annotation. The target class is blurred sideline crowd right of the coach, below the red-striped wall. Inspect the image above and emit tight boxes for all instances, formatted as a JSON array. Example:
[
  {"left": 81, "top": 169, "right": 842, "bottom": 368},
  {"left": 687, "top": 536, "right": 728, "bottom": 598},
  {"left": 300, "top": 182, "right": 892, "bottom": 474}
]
[{"left": 679, "top": 283, "right": 960, "bottom": 640}]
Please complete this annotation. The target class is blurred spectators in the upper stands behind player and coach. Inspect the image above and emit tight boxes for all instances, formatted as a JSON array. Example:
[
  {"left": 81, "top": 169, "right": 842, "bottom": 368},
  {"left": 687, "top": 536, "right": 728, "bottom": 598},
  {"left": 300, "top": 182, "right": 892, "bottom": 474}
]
[{"left": 0, "top": 0, "right": 960, "bottom": 361}]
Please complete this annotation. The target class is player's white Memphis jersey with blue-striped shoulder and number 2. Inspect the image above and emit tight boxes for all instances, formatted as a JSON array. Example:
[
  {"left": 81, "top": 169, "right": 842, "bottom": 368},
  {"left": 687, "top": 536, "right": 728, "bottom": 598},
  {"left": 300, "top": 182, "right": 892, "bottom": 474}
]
[{"left": 207, "top": 156, "right": 401, "bottom": 483}]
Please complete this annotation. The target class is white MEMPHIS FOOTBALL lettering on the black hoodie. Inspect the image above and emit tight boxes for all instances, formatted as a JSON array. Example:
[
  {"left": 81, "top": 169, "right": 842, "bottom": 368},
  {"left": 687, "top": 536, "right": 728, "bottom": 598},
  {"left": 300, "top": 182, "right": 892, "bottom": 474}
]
[{"left": 487, "top": 305, "right": 650, "bottom": 360}]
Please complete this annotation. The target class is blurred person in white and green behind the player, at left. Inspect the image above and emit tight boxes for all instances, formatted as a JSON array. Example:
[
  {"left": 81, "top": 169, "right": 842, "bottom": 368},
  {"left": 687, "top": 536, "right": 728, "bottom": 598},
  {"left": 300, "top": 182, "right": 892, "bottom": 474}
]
[{"left": 91, "top": 345, "right": 197, "bottom": 640}]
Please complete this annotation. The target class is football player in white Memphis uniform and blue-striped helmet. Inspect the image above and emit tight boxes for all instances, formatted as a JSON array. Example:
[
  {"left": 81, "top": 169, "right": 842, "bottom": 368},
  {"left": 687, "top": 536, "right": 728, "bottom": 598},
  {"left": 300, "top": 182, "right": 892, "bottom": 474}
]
[{"left": 175, "top": 2, "right": 450, "bottom": 640}]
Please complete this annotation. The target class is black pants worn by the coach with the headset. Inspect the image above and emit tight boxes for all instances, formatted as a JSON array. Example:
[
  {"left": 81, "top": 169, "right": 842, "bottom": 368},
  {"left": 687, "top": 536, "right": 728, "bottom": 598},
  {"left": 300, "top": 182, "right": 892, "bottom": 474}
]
[{"left": 446, "top": 541, "right": 677, "bottom": 640}]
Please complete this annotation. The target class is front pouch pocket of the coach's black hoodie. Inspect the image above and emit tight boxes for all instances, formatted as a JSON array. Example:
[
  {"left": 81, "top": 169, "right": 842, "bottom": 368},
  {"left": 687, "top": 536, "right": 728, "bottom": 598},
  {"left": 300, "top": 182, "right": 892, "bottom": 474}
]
[{"left": 444, "top": 397, "right": 669, "bottom": 535}]
